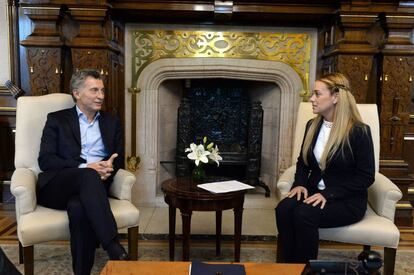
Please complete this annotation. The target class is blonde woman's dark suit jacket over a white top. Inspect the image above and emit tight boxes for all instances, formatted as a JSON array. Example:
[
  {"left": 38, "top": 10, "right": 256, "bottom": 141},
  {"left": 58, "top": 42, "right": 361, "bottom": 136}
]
[{"left": 292, "top": 118, "right": 375, "bottom": 215}]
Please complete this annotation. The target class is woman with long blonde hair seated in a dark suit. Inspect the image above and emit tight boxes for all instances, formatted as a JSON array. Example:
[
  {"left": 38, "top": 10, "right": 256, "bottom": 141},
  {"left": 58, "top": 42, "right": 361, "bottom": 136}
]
[{"left": 276, "top": 73, "right": 375, "bottom": 263}]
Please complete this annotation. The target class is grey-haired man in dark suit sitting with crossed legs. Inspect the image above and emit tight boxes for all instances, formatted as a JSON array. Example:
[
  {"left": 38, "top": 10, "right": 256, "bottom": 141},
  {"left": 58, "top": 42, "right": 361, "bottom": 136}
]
[{"left": 37, "top": 70, "right": 128, "bottom": 274}]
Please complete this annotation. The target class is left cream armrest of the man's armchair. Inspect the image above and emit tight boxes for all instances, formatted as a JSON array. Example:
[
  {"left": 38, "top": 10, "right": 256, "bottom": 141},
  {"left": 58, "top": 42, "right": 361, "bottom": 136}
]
[{"left": 10, "top": 168, "right": 37, "bottom": 220}]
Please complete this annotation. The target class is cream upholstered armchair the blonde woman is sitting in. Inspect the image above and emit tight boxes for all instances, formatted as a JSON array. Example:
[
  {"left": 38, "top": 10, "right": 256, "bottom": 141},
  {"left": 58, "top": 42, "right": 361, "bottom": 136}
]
[{"left": 276, "top": 102, "right": 402, "bottom": 275}]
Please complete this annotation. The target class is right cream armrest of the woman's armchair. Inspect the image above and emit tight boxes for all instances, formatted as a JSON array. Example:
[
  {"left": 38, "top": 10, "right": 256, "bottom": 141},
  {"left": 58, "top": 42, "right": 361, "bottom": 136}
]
[{"left": 368, "top": 172, "right": 402, "bottom": 221}]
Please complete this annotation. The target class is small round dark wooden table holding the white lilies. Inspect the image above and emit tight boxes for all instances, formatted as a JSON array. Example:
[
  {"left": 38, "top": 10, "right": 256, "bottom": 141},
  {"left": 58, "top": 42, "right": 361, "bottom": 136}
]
[{"left": 161, "top": 178, "right": 246, "bottom": 262}]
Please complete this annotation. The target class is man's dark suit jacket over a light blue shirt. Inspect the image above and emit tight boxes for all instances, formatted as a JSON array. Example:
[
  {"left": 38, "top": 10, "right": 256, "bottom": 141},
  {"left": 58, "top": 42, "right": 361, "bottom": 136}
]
[{"left": 37, "top": 106, "right": 124, "bottom": 188}]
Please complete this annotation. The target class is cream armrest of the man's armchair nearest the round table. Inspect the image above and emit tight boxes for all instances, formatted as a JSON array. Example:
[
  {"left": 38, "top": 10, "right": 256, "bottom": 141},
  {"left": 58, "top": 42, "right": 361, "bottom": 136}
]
[{"left": 109, "top": 169, "right": 135, "bottom": 201}]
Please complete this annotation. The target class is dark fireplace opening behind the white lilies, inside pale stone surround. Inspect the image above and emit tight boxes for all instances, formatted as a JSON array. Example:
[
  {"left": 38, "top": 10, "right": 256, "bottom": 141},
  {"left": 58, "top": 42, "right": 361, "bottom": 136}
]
[{"left": 176, "top": 79, "right": 270, "bottom": 196}]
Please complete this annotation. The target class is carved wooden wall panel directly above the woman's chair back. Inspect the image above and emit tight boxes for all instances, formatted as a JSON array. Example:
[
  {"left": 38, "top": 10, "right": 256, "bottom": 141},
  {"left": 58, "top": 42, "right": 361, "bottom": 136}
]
[{"left": 336, "top": 55, "right": 373, "bottom": 103}]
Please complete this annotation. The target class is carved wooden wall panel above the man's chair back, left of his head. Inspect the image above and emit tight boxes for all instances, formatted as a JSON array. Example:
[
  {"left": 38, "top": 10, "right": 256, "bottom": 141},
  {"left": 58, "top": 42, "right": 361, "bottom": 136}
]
[{"left": 27, "top": 47, "right": 61, "bottom": 95}]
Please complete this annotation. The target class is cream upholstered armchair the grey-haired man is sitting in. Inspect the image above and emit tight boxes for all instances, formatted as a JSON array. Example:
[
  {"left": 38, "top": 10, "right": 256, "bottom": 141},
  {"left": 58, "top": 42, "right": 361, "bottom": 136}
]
[{"left": 10, "top": 94, "right": 139, "bottom": 275}]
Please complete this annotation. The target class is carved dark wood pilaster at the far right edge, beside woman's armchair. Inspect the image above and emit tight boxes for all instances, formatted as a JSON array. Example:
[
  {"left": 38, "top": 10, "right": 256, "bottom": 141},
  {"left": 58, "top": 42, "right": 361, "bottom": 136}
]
[{"left": 380, "top": 56, "right": 414, "bottom": 226}]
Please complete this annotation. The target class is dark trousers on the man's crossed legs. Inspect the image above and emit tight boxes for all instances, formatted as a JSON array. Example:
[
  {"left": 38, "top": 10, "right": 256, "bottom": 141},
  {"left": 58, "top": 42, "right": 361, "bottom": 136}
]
[{"left": 37, "top": 168, "right": 117, "bottom": 274}]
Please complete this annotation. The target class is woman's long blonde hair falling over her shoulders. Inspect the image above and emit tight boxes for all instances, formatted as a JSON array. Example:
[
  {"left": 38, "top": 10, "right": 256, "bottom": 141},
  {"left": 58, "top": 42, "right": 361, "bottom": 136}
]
[{"left": 302, "top": 73, "right": 362, "bottom": 171}]
